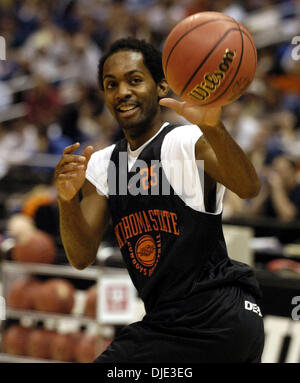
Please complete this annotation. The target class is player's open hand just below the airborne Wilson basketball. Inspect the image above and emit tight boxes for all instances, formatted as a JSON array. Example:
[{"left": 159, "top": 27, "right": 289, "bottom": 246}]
[{"left": 159, "top": 98, "right": 222, "bottom": 127}]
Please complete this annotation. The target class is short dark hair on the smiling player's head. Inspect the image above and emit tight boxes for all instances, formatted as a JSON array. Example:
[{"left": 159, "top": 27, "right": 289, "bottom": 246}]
[{"left": 98, "top": 37, "right": 164, "bottom": 90}]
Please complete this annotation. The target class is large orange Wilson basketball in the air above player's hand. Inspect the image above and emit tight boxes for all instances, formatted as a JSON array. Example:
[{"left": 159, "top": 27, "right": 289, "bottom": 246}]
[{"left": 162, "top": 12, "right": 257, "bottom": 107}]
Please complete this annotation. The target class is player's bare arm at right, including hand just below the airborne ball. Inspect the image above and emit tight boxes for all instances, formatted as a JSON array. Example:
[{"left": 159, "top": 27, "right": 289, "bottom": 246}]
[{"left": 160, "top": 98, "right": 260, "bottom": 198}]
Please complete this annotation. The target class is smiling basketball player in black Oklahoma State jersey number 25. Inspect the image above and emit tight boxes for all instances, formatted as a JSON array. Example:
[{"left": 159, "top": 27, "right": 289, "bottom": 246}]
[{"left": 55, "top": 38, "right": 264, "bottom": 363}]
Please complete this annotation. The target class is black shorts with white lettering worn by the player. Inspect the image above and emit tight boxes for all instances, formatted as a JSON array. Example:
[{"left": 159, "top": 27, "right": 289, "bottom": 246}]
[{"left": 94, "top": 286, "right": 264, "bottom": 363}]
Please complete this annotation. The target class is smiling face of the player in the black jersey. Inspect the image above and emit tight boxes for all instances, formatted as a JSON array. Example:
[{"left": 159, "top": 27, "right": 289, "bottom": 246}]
[{"left": 103, "top": 51, "right": 164, "bottom": 135}]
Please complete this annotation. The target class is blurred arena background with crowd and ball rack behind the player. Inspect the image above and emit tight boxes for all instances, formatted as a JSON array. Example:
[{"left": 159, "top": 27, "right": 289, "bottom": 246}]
[{"left": 0, "top": 0, "right": 300, "bottom": 363}]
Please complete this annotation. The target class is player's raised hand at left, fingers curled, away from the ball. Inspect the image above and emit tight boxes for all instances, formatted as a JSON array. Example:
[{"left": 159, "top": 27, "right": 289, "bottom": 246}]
[{"left": 54, "top": 142, "right": 94, "bottom": 201}]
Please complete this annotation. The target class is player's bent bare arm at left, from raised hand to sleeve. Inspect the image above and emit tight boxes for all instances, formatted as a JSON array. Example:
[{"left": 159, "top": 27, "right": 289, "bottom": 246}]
[{"left": 55, "top": 143, "right": 109, "bottom": 269}]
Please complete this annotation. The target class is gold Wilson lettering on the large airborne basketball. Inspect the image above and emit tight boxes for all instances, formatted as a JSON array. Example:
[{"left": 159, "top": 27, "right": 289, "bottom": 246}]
[{"left": 189, "top": 48, "right": 236, "bottom": 101}]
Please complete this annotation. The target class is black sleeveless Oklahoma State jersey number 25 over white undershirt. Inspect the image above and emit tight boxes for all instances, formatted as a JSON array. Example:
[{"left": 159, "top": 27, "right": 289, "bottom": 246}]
[{"left": 108, "top": 125, "right": 261, "bottom": 315}]
